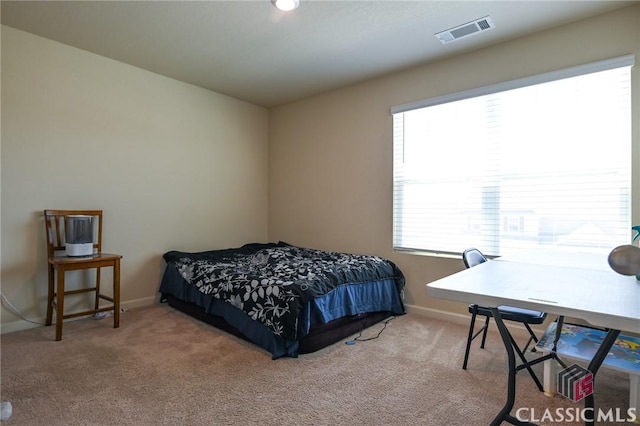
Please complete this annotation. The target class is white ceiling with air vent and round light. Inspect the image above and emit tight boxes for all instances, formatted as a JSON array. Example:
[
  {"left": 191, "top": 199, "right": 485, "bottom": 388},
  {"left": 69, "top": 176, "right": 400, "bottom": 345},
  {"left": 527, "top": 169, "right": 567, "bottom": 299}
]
[{"left": 1, "top": 0, "right": 634, "bottom": 107}]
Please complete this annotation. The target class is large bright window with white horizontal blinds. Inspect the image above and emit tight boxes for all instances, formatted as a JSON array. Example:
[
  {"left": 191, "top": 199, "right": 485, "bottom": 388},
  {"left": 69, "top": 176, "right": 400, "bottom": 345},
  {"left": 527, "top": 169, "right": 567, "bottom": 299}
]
[{"left": 392, "top": 55, "right": 634, "bottom": 255}]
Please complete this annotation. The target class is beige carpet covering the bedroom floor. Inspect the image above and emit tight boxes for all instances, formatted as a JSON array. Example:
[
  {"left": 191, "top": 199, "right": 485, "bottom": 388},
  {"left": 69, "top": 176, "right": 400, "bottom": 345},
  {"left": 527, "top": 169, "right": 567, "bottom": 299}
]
[{"left": 1, "top": 305, "right": 629, "bottom": 426}]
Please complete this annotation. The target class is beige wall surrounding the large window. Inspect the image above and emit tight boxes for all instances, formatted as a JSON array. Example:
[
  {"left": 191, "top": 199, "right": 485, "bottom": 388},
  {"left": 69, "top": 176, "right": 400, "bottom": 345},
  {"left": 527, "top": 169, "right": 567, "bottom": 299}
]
[{"left": 269, "top": 5, "right": 640, "bottom": 318}]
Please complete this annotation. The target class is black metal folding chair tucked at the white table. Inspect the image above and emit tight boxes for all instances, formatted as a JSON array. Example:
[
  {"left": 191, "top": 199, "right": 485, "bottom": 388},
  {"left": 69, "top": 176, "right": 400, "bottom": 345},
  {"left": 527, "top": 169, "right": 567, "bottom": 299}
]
[{"left": 462, "top": 248, "right": 547, "bottom": 372}]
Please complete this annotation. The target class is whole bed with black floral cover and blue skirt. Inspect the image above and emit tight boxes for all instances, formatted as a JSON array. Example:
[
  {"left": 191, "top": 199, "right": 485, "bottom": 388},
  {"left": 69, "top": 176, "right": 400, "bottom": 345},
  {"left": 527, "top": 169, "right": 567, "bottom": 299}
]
[{"left": 159, "top": 242, "right": 405, "bottom": 359}]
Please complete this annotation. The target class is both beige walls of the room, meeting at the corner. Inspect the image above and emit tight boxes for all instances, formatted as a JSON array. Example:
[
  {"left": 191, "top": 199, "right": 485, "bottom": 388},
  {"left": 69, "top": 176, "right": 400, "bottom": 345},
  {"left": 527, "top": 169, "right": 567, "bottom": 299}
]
[{"left": 0, "top": 5, "right": 640, "bottom": 332}]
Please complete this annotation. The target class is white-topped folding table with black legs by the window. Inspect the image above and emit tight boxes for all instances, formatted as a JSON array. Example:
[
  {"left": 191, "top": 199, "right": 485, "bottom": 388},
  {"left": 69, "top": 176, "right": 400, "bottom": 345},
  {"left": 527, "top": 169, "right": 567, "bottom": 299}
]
[{"left": 427, "top": 250, "right": 640, "bottom": 425}]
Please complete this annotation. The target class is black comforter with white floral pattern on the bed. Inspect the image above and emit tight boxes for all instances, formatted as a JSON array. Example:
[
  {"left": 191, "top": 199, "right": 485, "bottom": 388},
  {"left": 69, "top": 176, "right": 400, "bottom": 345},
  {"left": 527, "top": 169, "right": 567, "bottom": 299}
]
[{"left": 164, "top": 243, "right": 405, "bottom": 340}]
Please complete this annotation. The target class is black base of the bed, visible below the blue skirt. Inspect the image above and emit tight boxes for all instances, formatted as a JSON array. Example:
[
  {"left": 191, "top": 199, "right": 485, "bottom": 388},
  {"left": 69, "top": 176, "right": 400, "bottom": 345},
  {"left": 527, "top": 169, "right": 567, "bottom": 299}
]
[{"left": 164, "top": 294, "right": 393, "bottom": 354}]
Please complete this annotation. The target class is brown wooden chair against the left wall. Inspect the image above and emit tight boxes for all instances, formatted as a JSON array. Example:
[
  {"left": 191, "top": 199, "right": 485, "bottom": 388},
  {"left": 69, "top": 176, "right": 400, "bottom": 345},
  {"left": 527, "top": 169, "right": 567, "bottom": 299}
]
[{"left": 44, "top": 210, "right": 122, "bottom": 341}]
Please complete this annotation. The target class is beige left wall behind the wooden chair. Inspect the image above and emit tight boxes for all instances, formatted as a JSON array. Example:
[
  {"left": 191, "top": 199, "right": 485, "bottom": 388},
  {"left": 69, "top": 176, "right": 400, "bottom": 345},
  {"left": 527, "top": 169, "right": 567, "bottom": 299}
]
[{"left": 0, "top": 26, "right": 268, "bottom": 332}]
